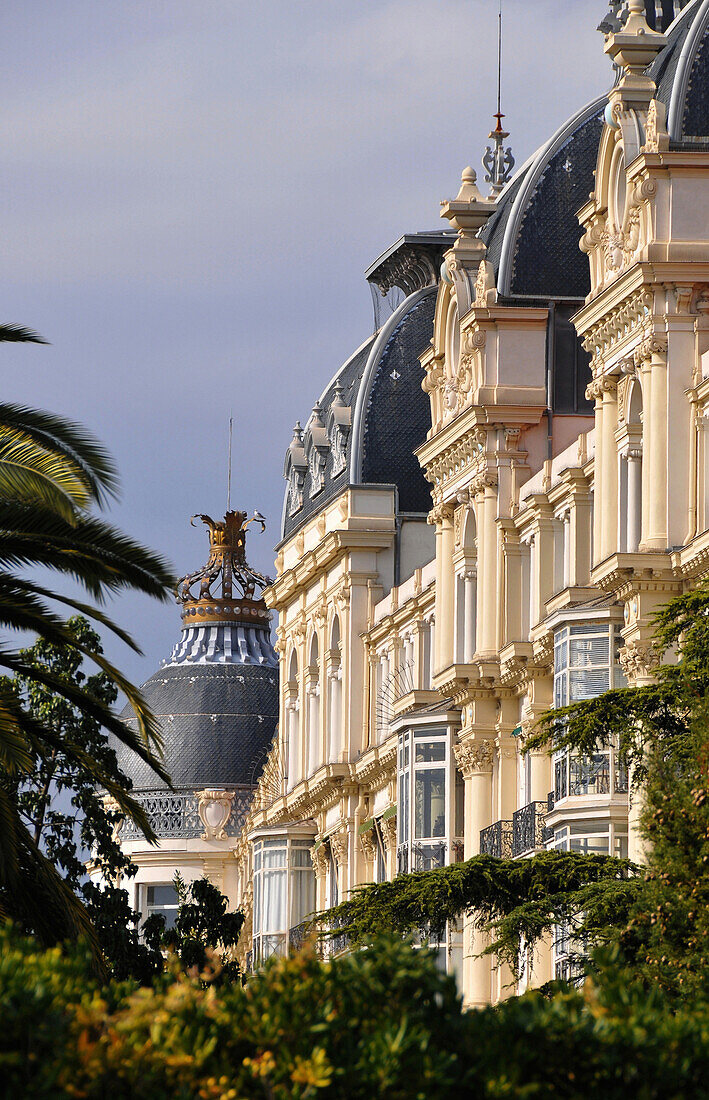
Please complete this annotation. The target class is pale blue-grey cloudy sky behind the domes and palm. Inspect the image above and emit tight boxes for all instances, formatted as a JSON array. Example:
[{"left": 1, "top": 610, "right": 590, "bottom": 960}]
[{"left": 0, "top": 0, "right": 611, "bottom": 682}]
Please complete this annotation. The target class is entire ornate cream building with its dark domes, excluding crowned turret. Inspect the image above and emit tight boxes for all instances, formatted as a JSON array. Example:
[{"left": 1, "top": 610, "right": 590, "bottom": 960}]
[{"left": 115, "top": 0, "right": 709, "bottom": 1005}]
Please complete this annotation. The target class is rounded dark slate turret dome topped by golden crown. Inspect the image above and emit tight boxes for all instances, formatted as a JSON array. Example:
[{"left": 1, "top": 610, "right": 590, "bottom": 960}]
[{"left": 112, "top": 512, "right": 278, "bottom": 792}]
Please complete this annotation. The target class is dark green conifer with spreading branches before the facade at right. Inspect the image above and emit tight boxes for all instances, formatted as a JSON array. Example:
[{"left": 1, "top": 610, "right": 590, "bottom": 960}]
[{"left": 318, "top": 583, "right": 709, "bottom": 996}]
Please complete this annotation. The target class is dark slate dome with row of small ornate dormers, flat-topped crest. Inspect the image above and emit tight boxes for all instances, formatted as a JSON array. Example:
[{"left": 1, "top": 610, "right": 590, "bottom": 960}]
[{"left": 281, "top": 232, "right": 454, "bottom": 538}]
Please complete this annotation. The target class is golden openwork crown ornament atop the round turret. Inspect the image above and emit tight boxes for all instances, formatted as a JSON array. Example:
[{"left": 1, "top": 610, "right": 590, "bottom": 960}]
[{"left": 176, "top": 512, "right": 273, "bottom": 628}]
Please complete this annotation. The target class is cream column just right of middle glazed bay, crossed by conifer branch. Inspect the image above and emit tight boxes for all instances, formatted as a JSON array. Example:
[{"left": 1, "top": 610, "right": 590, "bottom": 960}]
[{"left": 455, "top": 739, "right": 495, "bottom": 1008}]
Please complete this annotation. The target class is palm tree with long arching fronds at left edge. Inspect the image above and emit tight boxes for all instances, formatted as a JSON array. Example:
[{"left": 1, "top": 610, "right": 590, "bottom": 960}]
[{"left": 0, "top": 325, "right": 173, "bottom": 959}]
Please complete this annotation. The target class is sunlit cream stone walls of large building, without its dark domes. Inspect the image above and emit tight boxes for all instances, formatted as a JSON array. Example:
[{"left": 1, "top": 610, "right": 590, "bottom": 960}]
[{"left": 240, "top": 6, "right": 709, "bottom": 1005}]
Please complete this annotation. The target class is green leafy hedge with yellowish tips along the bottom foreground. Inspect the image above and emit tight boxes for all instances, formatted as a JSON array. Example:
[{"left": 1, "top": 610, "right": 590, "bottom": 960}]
[{"left": 0, "top": 930, "right": 709, "bottom": 1100}]
